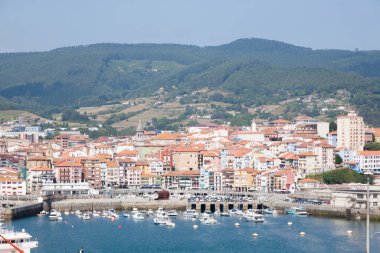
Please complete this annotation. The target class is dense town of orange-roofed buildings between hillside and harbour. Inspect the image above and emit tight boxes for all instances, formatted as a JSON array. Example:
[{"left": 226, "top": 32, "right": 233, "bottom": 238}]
[{"left": 0, "top": 111, "right": 380, "bottom": 211}]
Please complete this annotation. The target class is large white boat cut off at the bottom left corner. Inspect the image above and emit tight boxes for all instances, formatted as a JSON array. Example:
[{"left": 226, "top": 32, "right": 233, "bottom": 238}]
[{"left": 0, "top": 225, "right": 38, "bottom": 253}]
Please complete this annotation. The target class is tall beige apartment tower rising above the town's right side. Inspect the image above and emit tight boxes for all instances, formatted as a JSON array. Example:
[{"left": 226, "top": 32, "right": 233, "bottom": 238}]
[{"left": 337, "top": 112, "right": 365, "bottom": 151}]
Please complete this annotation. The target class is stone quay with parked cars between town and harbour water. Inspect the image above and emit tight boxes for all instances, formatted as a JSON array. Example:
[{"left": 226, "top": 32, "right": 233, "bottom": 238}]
[{"left": 0, "top": 189, "right": 380, "bottom": 221}]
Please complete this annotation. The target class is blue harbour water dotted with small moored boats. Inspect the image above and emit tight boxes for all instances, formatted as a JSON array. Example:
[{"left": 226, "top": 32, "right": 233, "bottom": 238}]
[{"left": 6, "top": 215, "right": 380, "bottom": 253}]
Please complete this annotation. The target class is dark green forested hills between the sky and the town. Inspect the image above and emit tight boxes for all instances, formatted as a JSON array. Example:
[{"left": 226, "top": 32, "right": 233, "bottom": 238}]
[{"left": 0, "top": 39, "right": 380, "bottom": 125}]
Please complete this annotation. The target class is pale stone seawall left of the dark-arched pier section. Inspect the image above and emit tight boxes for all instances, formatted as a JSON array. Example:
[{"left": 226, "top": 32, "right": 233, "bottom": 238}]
[{"left": 51, "top": 199, "right": 186, "bottom": 211}]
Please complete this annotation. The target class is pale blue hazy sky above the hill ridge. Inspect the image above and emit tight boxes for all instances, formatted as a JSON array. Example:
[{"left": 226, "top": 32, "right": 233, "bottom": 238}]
[{"left": 0, "top": 0, "right": 380, "bottom": 52}]
